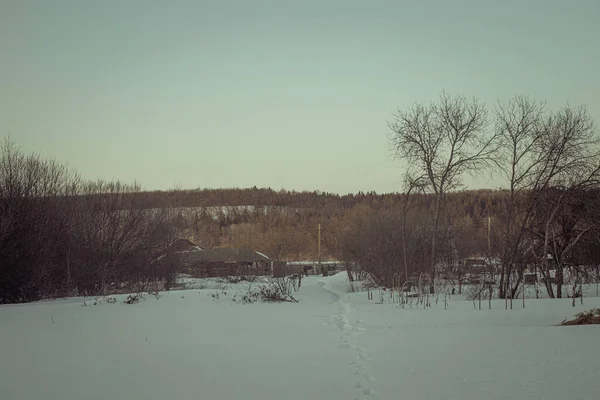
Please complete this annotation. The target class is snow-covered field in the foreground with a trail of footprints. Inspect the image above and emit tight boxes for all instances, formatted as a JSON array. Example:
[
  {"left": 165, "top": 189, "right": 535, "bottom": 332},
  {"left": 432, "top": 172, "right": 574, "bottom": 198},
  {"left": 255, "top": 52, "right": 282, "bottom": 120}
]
[{"left": 0, "top": 273, "right": 600, "bottom": 400}]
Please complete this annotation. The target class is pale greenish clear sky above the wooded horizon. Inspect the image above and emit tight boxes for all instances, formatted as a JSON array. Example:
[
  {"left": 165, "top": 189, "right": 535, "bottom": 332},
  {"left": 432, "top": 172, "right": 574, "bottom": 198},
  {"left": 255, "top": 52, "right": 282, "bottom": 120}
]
[{"left": 0, "top": 0, "right": 600, "bottom": 193}]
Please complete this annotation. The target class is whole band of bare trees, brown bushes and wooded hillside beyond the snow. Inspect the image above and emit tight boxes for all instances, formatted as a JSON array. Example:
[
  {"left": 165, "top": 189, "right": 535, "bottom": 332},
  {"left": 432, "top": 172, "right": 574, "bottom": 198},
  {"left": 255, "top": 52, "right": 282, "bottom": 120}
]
[{"left": 0, "top": 94, "right": 600, "bottom": 303}]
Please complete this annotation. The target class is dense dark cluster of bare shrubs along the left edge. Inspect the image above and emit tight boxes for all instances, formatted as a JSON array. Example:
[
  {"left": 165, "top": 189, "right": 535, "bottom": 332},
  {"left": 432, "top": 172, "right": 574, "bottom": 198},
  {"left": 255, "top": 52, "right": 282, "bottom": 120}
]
[{"left": 0, "top": 139, "right": 175, "bottom": 303}]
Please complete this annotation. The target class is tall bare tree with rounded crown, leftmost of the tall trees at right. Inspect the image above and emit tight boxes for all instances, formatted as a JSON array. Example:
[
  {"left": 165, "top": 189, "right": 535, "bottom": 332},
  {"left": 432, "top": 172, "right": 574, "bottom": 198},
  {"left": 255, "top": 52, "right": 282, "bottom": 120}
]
[{"left": 389, "top": 93, "right": 499, "bottom": 293}]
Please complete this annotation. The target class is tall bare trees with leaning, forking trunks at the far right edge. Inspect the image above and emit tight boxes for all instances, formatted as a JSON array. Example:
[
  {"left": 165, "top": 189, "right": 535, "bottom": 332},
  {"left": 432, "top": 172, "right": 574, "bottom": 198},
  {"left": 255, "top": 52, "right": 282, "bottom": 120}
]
[{"left": 496, "top": 96, "right": 600, "bottom": 298}]
